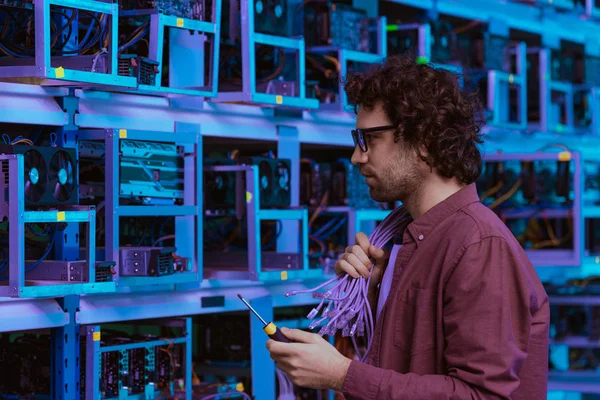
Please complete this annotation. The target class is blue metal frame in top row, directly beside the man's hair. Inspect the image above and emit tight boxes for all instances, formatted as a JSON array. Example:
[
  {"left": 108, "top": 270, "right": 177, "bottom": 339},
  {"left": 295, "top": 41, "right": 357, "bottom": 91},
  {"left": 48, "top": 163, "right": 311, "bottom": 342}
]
[{"left": 307, "top": 16, "right": 387, "bottom": 112}]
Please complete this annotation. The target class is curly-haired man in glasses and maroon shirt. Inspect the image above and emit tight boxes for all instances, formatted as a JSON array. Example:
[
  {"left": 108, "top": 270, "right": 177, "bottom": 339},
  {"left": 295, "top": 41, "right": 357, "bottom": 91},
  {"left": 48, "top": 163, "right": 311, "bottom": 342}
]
[{"left": 267, "top": 57, "right": 550, "bottom": 400}]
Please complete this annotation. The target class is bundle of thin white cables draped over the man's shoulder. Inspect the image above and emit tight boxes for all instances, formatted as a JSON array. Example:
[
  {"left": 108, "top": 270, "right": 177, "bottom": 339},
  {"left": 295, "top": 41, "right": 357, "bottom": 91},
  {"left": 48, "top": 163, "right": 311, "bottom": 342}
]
[{"left": 286, "top": 206, "right": 411, "bottom": 361}]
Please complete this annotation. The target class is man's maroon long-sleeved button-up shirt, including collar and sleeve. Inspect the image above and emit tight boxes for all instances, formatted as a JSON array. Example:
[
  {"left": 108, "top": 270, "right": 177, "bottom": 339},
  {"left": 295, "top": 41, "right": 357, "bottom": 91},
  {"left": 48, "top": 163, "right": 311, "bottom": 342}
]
[{"left": 343, "top": 184, "right": 550, "bottom": 400}]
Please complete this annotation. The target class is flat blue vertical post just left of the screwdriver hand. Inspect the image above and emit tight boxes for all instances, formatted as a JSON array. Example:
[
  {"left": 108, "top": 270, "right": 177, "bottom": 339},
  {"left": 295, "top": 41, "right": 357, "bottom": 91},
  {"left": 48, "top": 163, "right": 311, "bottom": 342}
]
[{"left": 249, "top": 296, "right": 277, "bottom": 399}]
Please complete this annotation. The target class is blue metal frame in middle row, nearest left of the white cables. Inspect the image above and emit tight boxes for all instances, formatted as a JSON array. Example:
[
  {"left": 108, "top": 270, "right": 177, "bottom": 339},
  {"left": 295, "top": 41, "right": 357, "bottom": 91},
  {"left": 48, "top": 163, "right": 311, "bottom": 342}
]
[{"left": 204, "top": 165, "right": 316, "bottom": 281}]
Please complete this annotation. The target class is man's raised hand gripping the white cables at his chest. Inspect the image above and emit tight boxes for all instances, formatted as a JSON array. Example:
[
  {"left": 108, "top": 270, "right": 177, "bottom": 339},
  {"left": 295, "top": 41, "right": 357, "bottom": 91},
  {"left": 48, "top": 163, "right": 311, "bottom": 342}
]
[{"left": 335, "top": 232, "right": 389, "bottom": 306}]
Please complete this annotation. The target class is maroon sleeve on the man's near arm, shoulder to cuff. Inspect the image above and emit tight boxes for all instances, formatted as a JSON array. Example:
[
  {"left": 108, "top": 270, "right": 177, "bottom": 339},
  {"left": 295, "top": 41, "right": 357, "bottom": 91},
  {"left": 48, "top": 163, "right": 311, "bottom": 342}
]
[{"left": 343, "top": 237, "right": 536, "bottom": 400}]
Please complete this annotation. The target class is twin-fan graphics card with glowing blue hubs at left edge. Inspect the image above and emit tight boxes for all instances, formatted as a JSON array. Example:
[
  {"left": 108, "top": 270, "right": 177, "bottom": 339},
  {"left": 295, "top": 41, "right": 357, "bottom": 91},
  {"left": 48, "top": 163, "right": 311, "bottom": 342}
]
[{"left": 0, "top": 145, "right": 79, "bottom": 206}]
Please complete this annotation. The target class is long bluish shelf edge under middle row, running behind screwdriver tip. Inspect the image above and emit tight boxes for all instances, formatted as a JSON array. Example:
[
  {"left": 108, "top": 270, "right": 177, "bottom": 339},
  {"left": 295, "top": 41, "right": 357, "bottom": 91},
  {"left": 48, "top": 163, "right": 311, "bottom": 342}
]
[{"left": 76, "top": 280, "right": 332, "bottom": 325}]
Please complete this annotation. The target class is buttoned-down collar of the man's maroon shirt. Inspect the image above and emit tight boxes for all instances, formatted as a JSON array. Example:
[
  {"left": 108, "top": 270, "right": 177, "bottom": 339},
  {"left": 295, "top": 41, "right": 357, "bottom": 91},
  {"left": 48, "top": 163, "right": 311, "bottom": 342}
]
[{"left": 404, "top": 183, "right": 479, "bottom": 246}]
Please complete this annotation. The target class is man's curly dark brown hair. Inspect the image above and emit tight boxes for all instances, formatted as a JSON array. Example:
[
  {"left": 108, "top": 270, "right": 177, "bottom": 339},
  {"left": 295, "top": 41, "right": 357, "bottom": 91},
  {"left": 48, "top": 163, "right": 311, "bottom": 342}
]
[{"left": 344, "top": 55, "right": 483, "bottom": 184}]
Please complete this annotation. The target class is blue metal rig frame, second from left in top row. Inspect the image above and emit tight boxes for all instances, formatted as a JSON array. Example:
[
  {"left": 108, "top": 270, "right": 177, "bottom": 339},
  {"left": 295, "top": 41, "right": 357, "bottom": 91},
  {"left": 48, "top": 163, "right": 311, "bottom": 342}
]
[{"left": 121, "top": 0, "right": 223, "bottom": 97}]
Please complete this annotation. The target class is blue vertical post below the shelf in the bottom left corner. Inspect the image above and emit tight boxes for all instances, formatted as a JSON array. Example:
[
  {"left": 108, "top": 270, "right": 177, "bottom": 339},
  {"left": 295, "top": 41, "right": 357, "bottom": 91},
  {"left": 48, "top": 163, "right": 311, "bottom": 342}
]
[{"left": 51, "top": 295, "right": 80, "bottom": 400}]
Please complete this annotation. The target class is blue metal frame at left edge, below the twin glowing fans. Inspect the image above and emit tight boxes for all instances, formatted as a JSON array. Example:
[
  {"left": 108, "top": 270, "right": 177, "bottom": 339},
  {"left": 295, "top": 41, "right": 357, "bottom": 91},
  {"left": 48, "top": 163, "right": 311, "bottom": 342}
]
[{"left": 0, "top": 154, "right": 115, "bottom": 297}]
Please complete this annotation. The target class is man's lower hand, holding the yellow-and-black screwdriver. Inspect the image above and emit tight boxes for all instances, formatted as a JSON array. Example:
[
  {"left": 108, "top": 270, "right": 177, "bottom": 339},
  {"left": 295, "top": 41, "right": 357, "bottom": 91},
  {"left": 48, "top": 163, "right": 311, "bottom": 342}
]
[{"left": 267, "top": 328, "right": 351, "bottom": 391}]
